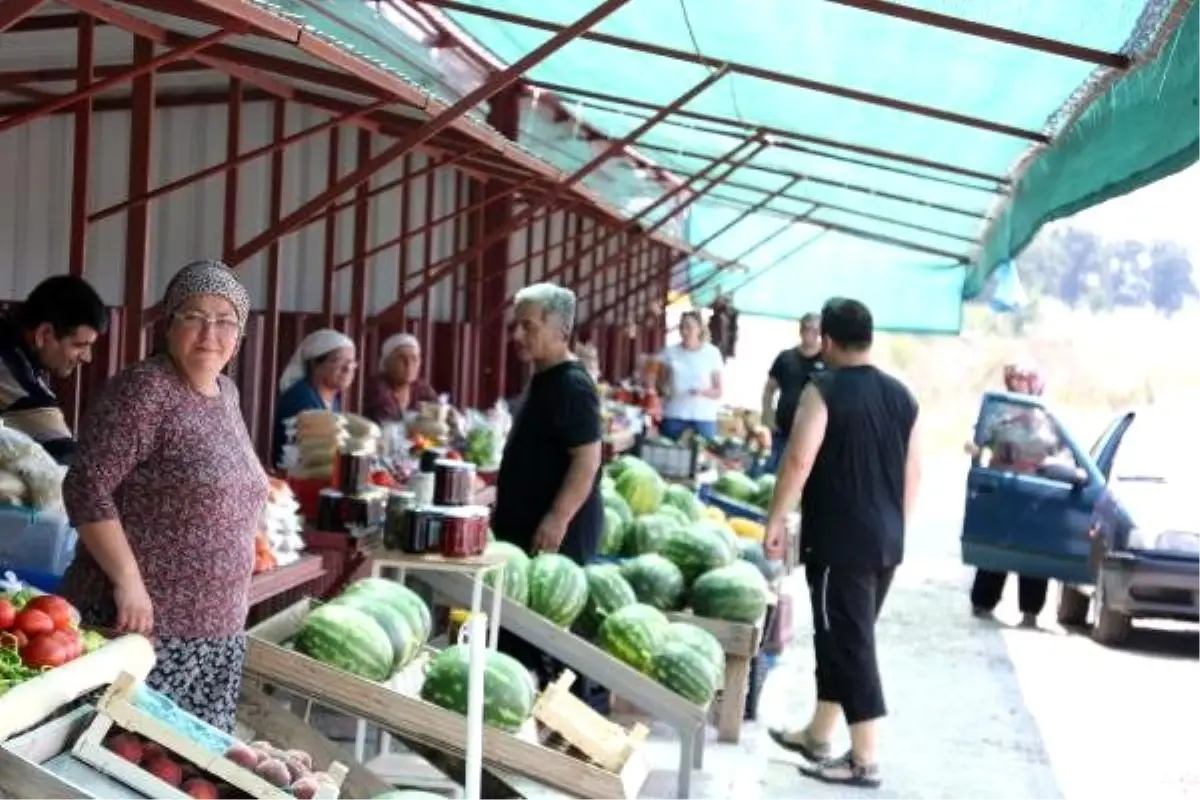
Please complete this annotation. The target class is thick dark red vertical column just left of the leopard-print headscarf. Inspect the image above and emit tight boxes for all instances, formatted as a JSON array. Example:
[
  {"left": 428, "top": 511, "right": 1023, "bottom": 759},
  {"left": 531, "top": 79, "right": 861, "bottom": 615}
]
[{"left": 121, "top": 36, "right": 155, "bottom": 363}]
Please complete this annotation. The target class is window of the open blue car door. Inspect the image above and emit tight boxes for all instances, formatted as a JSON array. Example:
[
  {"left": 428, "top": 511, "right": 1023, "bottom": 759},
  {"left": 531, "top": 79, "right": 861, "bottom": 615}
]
[{"left": 974, "top": 398, "right": 1079, "bottom": 473}]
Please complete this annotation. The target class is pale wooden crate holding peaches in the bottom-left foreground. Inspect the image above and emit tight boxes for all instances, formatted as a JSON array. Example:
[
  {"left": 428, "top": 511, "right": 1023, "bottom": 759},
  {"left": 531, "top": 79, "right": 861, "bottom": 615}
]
[{"left": 72, "top": 674, "right": 347, "bottom": 800}]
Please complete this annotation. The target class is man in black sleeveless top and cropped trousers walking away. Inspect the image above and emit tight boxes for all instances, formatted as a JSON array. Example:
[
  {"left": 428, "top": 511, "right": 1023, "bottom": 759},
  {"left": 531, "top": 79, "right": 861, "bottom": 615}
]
[{"left": 767, "top": 297, "right": 920, "bottom": 788}]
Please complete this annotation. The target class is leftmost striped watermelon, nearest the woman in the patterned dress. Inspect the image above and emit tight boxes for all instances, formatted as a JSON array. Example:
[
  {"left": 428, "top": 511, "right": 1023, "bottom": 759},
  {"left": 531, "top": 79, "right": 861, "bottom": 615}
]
[{"left": 295, "top": 603, "right": 396, "bottom": 680}]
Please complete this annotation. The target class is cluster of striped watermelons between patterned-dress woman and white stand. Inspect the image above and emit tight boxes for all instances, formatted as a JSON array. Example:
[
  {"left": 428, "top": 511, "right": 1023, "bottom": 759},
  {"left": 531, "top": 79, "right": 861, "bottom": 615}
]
[{"left": 295, "top": 578, "right": 433, "bottom": 681}]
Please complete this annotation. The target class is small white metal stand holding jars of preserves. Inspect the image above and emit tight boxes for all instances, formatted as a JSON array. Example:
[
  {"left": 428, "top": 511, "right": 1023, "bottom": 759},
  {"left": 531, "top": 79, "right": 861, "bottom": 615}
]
[{"left": 354, "top": 551, "right": 506, "bottom": 800}]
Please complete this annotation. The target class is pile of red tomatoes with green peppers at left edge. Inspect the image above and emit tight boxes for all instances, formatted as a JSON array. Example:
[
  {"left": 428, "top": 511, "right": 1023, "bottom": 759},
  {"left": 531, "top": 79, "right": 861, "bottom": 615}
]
[{"left": 0, "top": 591, "right": 103, "bottom": 693}]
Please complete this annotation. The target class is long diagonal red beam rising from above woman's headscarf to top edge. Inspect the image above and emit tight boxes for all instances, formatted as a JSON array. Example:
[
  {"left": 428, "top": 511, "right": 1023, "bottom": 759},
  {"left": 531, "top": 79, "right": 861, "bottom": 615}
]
[{"left": 227, "top": 0, "right": 629, "bottom": 265}]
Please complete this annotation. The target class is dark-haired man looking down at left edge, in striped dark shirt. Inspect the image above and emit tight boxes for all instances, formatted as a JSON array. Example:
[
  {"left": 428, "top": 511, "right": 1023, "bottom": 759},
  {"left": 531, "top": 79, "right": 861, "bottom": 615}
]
[{"left": 0, "top": 275, "right": 108, "bottom": 464}]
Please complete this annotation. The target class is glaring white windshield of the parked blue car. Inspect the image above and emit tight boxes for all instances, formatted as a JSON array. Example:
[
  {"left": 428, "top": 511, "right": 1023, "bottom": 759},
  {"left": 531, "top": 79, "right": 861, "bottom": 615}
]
[{"left": 1110, "top": 414, "right": 1200, "bottom": 481}]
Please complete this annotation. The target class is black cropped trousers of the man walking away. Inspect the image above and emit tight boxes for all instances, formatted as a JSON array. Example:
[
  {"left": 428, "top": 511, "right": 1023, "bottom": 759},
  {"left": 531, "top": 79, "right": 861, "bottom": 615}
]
[{"left": 805, "top": 564, "right": 895, "bottom": 724}]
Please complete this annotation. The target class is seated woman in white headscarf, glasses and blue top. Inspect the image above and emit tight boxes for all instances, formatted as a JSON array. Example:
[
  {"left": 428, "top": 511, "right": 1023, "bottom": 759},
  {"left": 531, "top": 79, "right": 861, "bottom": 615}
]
[{"left": 271, "top": 327, "right": 359, "bottom": 465}]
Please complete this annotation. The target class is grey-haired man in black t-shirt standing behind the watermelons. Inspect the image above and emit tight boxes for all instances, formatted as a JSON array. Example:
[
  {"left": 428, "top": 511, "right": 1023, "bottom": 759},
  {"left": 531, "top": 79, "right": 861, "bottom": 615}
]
[{"left": 492, "top": 283, "right": 604, "bottom": 692}]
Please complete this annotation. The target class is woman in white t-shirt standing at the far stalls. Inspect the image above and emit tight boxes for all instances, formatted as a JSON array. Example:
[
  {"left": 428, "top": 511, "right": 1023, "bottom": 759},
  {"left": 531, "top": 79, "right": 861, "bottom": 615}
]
[{"left": 659, "top": 311, "right": 725, "bottom": 439}]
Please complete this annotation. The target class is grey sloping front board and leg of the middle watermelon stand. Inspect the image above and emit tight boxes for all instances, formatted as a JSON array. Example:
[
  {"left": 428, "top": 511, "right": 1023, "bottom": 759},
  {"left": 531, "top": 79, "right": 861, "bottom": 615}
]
[{"left": 422, "top": 573, "right": 708, "bottom": 798}]
